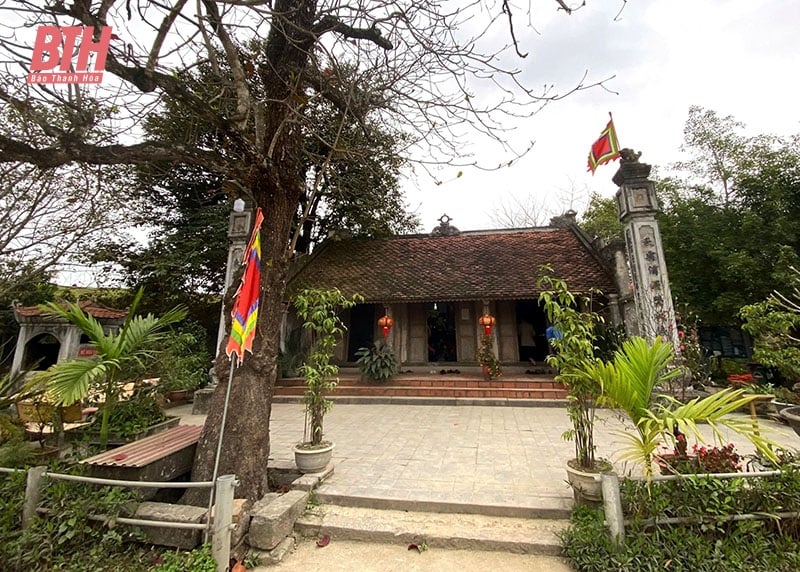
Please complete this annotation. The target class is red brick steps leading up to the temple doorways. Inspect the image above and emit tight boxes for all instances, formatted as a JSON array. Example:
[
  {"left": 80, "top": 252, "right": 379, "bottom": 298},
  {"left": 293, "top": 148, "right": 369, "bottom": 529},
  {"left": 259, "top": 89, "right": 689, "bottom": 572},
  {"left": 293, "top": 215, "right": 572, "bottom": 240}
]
[{"left": 274, "top": 366, "right": 567, "bottom": 407}]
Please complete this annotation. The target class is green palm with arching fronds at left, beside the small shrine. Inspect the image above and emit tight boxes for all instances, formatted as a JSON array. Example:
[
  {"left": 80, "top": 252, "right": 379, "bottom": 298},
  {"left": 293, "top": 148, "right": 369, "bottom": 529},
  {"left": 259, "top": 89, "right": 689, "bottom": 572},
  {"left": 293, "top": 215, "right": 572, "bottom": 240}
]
[{"left": 42, "top": 290, "right": 186, "bottom": 447}]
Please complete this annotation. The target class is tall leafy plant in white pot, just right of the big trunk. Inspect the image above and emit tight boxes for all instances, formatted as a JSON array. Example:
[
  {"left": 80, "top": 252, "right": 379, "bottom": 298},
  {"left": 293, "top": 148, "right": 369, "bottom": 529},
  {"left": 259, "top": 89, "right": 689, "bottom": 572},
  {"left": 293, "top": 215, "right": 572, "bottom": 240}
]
[{"left": 293, "top": 288, "right": 363, "bottom": 473}]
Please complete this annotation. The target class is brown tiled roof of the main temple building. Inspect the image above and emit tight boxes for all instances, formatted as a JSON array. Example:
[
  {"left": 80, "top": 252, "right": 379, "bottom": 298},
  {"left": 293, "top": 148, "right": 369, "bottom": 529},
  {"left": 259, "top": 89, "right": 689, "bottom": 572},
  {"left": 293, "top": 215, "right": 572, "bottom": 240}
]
[{"left": 289, "top": 227, "right": 616, "bottom": 302}]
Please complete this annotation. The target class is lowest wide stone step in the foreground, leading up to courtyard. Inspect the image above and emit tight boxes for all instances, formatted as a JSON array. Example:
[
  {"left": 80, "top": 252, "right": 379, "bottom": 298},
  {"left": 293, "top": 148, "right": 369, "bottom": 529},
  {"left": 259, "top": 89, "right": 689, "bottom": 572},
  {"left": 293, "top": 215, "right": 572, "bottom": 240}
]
[{"left": 295, "top": 504, "right": 568, "bottom": 555}]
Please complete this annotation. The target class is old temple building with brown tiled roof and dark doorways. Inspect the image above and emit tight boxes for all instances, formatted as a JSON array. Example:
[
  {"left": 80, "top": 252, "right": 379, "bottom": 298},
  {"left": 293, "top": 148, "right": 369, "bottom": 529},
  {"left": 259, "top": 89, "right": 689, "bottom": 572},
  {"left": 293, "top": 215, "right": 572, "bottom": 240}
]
[{"left": 287, "top": 211, "right": 627, "bottom": 366}]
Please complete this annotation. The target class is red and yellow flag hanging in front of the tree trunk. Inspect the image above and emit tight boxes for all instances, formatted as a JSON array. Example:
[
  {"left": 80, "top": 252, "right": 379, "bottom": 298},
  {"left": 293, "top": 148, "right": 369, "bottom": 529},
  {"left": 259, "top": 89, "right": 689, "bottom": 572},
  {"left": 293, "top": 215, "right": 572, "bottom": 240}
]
[{"left": 225, "top": 208, "right": 264, "bottom": 363}]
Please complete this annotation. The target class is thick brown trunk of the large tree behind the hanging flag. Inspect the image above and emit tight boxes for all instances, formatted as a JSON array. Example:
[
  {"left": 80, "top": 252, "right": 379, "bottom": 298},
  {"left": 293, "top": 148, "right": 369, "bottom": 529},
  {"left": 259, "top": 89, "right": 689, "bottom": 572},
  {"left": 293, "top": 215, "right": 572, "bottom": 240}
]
[{"left": 184, "top": 0, "right": 316, "bottom": 505}]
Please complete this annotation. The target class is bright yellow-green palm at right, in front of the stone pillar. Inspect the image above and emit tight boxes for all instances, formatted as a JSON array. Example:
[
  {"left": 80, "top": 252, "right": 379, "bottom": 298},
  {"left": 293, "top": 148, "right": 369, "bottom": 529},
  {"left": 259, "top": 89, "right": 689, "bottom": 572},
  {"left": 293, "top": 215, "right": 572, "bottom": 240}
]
[{"left": 582, "top": 338, "right": 775, "bottom": 476}]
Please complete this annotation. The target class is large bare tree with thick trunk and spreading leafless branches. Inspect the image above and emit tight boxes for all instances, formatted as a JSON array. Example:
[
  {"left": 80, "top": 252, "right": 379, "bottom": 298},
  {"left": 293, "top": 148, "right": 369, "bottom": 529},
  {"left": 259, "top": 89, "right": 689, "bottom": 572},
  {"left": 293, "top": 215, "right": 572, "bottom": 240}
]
[{"left": 0, "top": 0, "right": 608, "bottom": 498}]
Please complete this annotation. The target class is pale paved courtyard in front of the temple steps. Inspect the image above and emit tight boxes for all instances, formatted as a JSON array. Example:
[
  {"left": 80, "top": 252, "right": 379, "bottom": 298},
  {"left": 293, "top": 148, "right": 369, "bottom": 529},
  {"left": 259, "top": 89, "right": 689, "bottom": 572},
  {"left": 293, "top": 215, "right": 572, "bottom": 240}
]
[{"left": 173, "top": 404, "right": 800, "bottom": 508}]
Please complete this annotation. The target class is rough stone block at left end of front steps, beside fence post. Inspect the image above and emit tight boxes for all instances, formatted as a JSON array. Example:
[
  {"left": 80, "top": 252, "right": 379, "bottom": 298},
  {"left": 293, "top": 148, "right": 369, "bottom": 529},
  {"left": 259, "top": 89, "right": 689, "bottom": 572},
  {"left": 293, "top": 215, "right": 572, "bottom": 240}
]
[{"left": 248, "top": 490, "right": 308, "bottom": 550}]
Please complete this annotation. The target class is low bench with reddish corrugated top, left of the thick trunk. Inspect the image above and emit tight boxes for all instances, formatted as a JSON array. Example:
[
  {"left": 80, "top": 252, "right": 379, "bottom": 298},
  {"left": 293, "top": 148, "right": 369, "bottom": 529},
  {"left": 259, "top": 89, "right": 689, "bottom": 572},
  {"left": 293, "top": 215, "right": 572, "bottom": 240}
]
[{"left": 81, "top": 425, "right": 203, "bottom": 481}]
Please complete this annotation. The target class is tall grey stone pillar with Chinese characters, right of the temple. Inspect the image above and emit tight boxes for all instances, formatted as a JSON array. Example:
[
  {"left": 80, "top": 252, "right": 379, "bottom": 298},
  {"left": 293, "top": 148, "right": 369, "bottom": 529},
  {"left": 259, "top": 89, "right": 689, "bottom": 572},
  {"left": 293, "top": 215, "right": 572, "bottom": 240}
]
[{"left": 612, "top": 149, "right": 679, "bottom": 352}]
